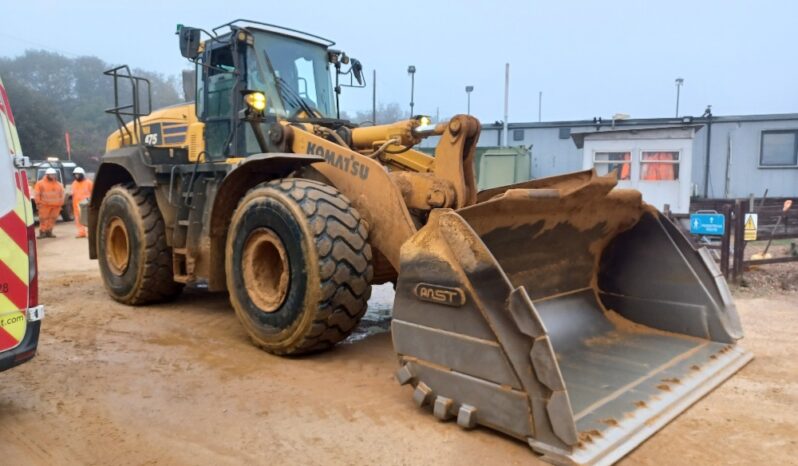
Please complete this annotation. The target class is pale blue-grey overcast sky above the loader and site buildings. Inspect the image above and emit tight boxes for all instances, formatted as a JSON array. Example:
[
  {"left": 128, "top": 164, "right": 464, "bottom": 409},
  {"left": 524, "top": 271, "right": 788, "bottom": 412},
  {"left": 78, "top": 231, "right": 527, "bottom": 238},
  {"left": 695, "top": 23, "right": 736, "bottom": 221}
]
[{"left": 0, "top": 0, "right": 798, "bottom": 122}]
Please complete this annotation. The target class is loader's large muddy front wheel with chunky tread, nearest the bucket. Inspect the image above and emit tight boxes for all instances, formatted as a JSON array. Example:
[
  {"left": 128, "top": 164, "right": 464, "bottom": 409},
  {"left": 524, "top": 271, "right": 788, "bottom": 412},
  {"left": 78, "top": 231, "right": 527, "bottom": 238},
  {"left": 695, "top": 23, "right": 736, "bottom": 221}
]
[{"left": 225, "top": 178, "right": 374, "bottom": 355}]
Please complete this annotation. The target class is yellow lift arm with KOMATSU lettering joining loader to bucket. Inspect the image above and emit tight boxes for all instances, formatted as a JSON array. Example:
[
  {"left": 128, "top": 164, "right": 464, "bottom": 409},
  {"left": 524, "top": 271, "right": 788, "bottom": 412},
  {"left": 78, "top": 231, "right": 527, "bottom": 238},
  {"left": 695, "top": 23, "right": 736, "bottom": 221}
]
[{"left": 281, "top": 115, "right": 480, "bottom": 271}]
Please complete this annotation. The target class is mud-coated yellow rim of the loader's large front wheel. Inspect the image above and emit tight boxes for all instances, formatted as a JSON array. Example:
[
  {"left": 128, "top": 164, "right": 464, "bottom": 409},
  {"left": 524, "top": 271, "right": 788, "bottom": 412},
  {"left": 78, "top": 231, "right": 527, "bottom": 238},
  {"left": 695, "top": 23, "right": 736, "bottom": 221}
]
[{"left": 247, "top": 228, "right": 291, "bottom": 313}]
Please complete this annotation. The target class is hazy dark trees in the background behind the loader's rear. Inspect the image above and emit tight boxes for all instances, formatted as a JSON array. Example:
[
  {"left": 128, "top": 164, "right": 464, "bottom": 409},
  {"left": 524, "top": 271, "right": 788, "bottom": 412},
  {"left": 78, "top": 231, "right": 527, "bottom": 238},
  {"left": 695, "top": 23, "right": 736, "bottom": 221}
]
[{"left": 0, "top": 50, "right": 182, "bottom": 169}]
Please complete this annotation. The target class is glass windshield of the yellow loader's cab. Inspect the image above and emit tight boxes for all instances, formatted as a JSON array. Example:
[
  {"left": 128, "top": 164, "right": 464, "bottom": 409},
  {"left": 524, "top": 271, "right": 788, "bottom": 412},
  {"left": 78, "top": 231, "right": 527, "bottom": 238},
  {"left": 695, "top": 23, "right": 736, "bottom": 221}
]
[{"left": 247, "top": 31, "right": 336, "bottom": 118}]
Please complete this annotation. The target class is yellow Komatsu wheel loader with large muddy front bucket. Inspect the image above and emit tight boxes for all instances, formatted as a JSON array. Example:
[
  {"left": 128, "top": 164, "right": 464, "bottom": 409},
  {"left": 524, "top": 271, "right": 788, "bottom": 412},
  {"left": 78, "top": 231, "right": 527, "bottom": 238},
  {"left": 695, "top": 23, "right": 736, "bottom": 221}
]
[{"left": 87, "top": 20, "right": 752, "bottom": 464}]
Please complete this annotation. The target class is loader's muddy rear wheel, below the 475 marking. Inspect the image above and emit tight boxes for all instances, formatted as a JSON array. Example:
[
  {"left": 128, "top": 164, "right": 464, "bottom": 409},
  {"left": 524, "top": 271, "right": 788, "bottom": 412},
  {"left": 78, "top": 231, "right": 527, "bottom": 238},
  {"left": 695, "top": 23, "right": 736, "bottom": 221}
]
[{"left": 96, "top": 184, "right": 183, "bottom": 305}]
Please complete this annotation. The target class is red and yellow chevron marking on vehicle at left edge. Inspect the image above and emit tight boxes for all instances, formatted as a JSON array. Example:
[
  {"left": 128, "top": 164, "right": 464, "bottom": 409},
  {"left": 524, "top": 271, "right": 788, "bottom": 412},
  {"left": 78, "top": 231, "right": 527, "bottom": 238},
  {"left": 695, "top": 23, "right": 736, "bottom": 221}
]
[{"left": 0, "top": 163, "right": 33, "bottom": 351}]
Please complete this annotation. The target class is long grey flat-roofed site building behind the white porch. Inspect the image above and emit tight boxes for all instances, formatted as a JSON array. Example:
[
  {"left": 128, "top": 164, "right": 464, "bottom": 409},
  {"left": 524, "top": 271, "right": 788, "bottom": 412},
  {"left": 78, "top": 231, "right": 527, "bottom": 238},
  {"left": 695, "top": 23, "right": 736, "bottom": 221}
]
[{"left": 479, "top": 113, "right": 798, "bottom": 207}]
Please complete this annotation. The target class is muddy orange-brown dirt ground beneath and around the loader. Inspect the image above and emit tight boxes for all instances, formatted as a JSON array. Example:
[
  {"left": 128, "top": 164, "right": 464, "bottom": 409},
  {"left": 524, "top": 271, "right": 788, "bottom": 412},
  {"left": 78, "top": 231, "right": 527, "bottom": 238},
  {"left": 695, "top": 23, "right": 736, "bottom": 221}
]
[{"left": 0, "top": 224, "right": 798, "bottom": 465}]
